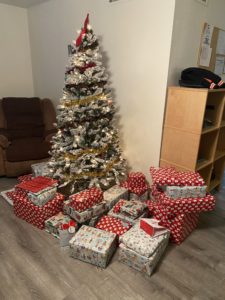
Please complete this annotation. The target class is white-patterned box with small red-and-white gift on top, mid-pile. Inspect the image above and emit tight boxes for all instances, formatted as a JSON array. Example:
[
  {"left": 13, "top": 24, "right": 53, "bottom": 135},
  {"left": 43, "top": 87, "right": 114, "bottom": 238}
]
[{"left": 108, "top": 199, "right": 148, "bottom": 225}]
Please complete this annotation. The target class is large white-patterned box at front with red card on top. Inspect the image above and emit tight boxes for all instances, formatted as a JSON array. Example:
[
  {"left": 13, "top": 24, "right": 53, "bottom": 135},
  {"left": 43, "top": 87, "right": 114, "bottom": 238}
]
[{"left": 119, "top": 222, "right": 169, "bottom": 276}]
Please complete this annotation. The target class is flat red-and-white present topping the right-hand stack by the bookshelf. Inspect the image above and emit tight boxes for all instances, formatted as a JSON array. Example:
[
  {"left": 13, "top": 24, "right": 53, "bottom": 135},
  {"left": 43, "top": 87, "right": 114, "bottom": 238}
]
[{"left": 150, "top": 167, "right": 205, "bottom": 186}]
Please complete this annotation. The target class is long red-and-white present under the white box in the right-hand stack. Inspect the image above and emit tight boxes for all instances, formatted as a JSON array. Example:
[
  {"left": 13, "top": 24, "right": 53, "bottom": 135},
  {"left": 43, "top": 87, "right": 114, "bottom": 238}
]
[{"left": 151, "top": 186, "right": 216, "bottom": 214}]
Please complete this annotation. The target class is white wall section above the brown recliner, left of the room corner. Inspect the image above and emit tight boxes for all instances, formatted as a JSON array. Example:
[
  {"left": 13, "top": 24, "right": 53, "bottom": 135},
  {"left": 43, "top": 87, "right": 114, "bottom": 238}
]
[{"left": 0, "top": 4, "right": 34, "bottom": 97}]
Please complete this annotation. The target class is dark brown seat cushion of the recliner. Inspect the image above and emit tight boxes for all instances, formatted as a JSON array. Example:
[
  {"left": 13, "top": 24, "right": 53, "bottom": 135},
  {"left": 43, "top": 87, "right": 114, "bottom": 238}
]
[{"left": 6, "top": 138, "right": 50, "bottom": 162}]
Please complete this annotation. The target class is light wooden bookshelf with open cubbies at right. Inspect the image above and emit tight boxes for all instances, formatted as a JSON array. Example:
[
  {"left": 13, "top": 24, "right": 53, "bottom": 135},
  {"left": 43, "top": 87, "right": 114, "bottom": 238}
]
[{"left": 160, "top": 87, "right": 225, "bottom": 190}]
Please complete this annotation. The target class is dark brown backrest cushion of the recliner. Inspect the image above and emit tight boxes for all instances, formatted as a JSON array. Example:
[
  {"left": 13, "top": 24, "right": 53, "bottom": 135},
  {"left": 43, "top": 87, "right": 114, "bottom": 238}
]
[{"left": 2, "top": 98, "right": 44, "bottom": 140}]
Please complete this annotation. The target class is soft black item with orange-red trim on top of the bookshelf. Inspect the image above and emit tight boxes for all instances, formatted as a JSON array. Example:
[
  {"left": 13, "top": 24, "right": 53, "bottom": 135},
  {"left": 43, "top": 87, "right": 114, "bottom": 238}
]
[{"left": 179, "top": 68, "right": 225, "bottom": 89}]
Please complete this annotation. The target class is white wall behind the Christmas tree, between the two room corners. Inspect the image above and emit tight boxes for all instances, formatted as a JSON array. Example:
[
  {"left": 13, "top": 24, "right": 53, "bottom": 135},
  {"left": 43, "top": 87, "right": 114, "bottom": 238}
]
[{"left": 28, "top": 0, "right": 175, "bottom": 174}]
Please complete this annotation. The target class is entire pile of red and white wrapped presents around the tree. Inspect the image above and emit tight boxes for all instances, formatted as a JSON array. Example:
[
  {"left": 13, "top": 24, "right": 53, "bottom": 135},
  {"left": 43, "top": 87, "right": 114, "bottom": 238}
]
[{"left": 5, "top": 164, "right": 215, "bottom": 276}]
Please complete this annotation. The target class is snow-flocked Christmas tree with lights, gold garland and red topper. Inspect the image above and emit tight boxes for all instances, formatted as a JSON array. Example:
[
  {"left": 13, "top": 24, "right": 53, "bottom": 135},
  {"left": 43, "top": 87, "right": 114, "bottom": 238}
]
[{"left": 49, "top": 15, "right": 126, "bottom": 193}]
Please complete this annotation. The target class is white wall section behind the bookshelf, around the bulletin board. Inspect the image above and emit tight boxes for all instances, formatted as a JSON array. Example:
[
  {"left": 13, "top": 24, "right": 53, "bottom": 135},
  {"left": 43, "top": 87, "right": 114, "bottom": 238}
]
[{"left": 168, "top": 0, "right": 225, "bottom": 85}]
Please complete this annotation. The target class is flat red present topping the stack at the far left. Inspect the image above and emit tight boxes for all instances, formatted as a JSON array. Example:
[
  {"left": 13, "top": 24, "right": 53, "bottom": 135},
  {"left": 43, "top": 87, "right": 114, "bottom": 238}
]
[{"left": 15, "top": 176, "right": 57, "bottom": 193}]
